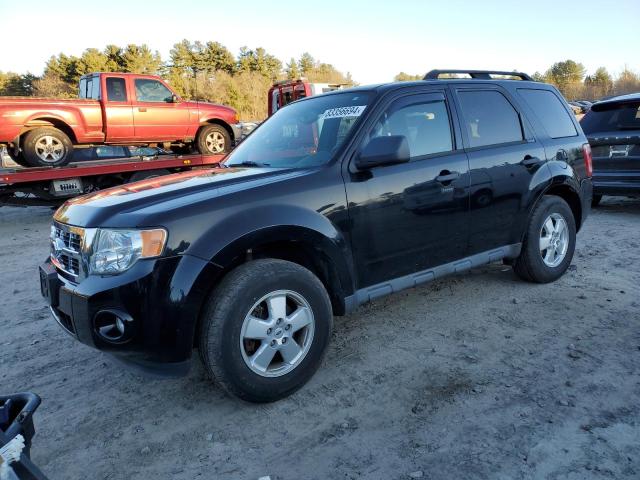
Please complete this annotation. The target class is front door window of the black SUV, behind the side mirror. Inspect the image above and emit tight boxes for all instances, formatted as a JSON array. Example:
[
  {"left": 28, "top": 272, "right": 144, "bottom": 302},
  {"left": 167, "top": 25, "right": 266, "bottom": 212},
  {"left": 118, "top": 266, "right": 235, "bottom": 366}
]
[{"left": 369, "top": 100, "right": 453, "bottom": 160}]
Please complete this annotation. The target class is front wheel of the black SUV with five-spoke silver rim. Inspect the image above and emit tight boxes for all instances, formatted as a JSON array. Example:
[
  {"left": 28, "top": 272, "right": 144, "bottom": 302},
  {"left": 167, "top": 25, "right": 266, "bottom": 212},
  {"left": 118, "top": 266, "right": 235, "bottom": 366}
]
[{"left": 198, "top": 259, "right": 333, "bottom": 403}]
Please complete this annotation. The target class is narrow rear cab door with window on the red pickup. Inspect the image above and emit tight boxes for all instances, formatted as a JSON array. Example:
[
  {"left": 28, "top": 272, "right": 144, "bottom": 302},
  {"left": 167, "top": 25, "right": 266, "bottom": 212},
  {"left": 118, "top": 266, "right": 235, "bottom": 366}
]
[{"left": 100, "top": 75, "right": 135, "bottom": 142}]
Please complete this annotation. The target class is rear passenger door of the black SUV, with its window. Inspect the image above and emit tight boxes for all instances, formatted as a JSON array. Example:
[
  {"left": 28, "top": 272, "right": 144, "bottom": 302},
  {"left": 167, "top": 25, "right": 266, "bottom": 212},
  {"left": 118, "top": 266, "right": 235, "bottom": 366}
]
[{"left": 453, "top": 83, "right": 545, "bottom": 255}]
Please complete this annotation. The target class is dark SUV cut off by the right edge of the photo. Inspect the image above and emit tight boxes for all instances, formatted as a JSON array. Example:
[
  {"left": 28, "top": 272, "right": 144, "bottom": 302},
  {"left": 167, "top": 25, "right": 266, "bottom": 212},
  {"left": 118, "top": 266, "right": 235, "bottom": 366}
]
[{"left": 580, "top": 93, "right": 640, "bottom": 206}]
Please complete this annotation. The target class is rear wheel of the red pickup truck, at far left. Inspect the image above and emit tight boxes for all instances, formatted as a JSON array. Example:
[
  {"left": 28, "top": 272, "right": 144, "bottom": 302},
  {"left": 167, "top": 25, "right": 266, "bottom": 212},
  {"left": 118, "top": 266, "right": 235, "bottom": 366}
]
[{"left": 22, "top": 127, "right": 73, "bottom": 167}]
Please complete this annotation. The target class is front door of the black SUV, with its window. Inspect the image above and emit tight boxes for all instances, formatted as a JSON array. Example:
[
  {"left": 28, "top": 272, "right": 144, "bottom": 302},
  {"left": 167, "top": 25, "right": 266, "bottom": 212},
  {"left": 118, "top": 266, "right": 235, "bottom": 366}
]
[{"left": 345, "top": 89, "right": 469, "bottom": 288}]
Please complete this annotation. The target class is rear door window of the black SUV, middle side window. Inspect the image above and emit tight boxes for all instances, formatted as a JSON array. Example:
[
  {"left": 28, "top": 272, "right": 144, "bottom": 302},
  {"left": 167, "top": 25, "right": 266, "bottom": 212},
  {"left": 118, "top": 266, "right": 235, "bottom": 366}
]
[{"left": 458, "top": 90, "right": 524, "bottom": 147}]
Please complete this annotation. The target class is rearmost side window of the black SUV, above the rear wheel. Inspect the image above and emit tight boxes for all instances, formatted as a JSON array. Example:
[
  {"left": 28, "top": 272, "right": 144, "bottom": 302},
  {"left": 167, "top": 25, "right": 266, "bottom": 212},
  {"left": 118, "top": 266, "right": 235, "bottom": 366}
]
[{"left": 518, "top": 88, "right": 578, "bottom": 138}]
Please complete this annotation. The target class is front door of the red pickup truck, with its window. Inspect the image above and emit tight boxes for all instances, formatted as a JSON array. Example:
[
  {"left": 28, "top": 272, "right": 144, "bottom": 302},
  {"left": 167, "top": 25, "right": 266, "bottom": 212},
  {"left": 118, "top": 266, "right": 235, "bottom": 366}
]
[{"left": 133, "top": 78, "right": 190, "bottom": 141}]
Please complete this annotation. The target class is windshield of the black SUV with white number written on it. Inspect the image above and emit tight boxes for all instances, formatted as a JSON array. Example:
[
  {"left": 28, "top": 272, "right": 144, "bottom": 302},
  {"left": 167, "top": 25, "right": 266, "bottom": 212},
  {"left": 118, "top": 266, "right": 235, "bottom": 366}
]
[{"left": 224, "top": 91, "right": 373, "bottom": 168}]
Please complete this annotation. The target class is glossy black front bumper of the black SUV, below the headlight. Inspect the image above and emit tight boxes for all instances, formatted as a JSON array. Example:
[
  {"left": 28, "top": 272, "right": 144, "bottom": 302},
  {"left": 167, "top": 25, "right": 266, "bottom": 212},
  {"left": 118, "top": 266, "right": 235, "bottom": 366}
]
[{"left": 40, "top": 255, "right": 220, "bottom": 376}]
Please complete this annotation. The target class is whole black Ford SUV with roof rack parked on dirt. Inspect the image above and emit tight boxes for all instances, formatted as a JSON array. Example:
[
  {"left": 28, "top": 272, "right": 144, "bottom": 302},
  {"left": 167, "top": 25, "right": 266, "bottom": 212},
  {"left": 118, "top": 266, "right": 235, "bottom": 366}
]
[{"left": 41, "top": 71, "right": 592, "bottom": 402}]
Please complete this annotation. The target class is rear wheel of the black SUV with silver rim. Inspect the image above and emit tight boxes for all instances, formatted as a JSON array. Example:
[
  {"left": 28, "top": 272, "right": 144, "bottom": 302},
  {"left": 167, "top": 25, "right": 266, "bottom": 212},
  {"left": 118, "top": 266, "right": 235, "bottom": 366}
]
[{"left": 513, "top": 195, "right": 576, "bottom": 283}]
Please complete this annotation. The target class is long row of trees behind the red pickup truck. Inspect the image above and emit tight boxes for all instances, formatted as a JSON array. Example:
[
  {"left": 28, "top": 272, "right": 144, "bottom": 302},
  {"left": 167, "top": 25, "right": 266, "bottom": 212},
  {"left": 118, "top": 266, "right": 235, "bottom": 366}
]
[{"left": 0, "top": 40, "right": 354, "bottom": 120}]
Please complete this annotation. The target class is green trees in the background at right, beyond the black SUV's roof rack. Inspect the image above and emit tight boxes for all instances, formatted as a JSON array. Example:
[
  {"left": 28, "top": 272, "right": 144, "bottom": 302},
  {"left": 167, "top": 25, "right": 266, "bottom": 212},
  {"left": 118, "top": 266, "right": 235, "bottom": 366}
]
[{"left": 394, "top": 60, "right": 640, "bottom": 101}]
